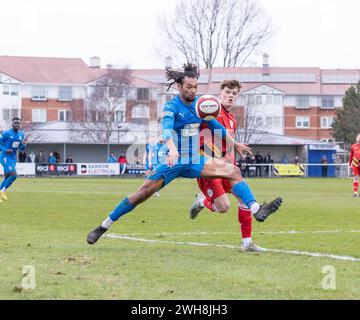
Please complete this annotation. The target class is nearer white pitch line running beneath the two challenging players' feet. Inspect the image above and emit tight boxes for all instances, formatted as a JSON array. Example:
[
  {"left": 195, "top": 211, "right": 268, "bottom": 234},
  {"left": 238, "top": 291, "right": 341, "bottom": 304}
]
[{"left": 104, "top": 233, "right": 360, "bottom": 261}]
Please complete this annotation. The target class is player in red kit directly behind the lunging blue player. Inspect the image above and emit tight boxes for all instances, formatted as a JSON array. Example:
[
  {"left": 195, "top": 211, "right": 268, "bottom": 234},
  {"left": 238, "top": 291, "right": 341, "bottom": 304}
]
[{"left": 189, "top": 80, "right": 264, "bottom": 251}]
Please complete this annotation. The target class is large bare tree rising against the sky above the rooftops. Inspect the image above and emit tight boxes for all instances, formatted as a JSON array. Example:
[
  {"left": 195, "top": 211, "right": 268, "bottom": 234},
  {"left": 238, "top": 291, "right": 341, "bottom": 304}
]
[{"left": 159, "top": 0, "right": 273, "bottom": 69}]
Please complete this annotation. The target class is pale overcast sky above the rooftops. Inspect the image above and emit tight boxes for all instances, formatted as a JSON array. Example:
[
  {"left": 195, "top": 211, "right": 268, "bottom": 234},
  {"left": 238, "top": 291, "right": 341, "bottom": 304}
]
[{"left": 0, "top": 0, "right": 360, "bottom": 68}]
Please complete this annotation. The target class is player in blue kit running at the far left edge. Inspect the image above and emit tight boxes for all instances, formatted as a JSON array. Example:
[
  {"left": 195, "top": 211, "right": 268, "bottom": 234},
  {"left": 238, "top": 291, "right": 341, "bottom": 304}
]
[{"left": 0, "top": 118, "right": 26, "bottom": 202}]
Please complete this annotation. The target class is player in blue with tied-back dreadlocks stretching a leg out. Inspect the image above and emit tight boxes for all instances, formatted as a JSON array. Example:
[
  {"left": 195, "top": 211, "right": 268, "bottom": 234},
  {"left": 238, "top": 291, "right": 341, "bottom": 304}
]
[{"left": 87, "top": 63, "right": 282, "bottom": 244}]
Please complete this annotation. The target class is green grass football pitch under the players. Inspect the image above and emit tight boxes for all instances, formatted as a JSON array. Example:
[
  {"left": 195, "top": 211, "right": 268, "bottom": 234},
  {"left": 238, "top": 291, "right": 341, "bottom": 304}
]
[{"left": 0, "top": 178, "right": 360, "bottom": 300}]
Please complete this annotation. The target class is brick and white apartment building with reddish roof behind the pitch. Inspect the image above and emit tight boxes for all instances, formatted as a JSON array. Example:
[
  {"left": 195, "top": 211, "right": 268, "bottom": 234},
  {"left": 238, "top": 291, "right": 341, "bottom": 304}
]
[{"left": 0, "top": 56, "right": 360, "bottom": 141}]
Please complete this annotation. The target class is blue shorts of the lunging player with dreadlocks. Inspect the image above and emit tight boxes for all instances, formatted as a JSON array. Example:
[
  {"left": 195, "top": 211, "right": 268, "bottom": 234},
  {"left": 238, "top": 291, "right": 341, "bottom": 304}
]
[{"left": 147, "top": 156, "right": 208, "bottom": 187}]
